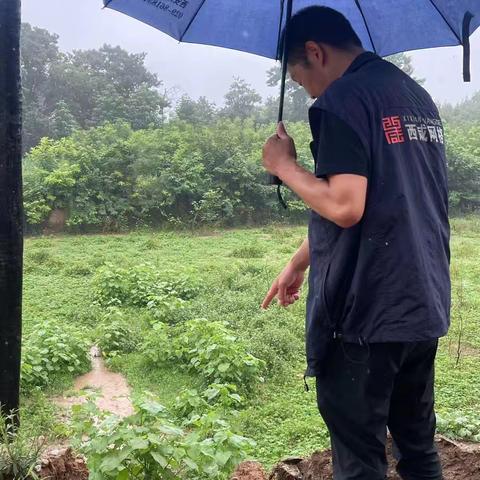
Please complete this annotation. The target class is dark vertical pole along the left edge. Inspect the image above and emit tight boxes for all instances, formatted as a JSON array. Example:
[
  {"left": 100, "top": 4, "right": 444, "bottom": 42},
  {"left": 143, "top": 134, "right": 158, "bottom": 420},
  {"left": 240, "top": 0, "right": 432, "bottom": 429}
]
[{"left": 0, "top": 0, "right": 23, "bottom": 420}]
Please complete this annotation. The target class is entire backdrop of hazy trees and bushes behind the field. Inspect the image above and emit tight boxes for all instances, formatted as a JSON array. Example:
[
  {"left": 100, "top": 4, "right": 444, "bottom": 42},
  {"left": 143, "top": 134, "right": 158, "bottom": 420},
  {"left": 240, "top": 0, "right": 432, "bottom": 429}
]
[{"left": 22, "top": 24, "right": 480, "bottom": 234}]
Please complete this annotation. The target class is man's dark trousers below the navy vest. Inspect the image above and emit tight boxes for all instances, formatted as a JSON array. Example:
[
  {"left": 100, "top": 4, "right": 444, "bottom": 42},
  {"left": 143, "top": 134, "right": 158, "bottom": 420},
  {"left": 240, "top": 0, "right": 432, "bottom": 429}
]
[{"left": 317, "top": 340, "right": 443, "bottom": 480}]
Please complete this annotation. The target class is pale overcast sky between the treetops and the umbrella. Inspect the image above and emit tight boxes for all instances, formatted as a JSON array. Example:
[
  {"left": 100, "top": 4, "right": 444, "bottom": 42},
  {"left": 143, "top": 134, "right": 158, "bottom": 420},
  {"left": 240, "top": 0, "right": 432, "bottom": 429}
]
[{"left": 22, "top": 0, "right": 480, "bottom": 104}]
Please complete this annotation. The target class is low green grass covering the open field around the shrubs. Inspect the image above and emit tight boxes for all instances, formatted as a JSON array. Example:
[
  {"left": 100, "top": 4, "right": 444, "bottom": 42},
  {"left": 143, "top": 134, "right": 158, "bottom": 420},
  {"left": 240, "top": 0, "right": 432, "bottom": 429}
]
[{"left": 23, "top": 218, "right": 480, "bottom": 465}]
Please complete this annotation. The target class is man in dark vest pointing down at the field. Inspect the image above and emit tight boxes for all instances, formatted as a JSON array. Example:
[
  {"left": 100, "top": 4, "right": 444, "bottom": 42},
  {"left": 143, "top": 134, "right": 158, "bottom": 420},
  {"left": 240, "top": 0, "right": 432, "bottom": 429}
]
[{"left": 262, "top": 7, "right": 450, "bottom": 480}]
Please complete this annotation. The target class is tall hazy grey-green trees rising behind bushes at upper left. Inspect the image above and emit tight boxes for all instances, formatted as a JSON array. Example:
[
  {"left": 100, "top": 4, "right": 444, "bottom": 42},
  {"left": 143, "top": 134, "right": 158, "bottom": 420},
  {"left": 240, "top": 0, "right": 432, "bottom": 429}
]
[{"left": 22, "top": 24, "right": 169, "bottom": 150}]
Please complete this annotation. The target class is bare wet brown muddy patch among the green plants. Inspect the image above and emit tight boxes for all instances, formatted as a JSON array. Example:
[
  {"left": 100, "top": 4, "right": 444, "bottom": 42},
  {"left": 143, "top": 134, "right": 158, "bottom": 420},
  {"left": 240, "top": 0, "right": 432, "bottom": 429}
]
[{"left": 53, "top": 347, "right": 133, "bottom": 417}]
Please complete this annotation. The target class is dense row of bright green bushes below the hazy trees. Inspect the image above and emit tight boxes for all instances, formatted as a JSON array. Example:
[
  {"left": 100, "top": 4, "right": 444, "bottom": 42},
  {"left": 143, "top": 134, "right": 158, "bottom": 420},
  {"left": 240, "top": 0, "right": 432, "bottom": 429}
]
[{"left": 24, "top": 119, "right": 480, "bottom": 232}]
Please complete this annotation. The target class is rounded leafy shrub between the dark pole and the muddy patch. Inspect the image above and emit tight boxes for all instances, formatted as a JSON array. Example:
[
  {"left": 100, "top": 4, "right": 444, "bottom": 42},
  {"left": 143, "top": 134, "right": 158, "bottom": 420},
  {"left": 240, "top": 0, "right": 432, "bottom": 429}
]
[{"left": 22, "top": 322, "right": 90, "bottom": 388}]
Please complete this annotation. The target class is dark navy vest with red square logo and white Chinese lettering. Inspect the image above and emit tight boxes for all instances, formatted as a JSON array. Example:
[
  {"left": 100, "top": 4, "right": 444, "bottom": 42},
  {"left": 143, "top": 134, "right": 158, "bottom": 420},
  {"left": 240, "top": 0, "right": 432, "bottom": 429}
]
[{"left": 306, "top": 53, "right": 450, "bottom": 375}]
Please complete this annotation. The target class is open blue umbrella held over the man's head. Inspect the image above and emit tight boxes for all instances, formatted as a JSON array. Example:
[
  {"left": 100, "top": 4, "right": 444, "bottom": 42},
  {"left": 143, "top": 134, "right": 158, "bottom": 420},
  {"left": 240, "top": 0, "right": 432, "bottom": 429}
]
[{"left": 104, "top": 0, "right": 480, "bottom": 199}]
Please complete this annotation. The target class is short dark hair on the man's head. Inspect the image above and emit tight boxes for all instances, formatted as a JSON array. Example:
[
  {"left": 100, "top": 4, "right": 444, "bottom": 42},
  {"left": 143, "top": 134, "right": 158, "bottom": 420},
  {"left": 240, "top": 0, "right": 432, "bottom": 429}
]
[{"left": 279, "top": 6, "right": 362, "bottom": 64}]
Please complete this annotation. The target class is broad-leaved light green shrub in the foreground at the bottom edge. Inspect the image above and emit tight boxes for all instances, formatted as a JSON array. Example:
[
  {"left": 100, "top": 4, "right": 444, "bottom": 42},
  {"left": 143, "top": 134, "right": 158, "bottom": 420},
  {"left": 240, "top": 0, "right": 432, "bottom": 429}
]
[{"left": 74, "top": 398, "right": 253, "bottom": 480}]
